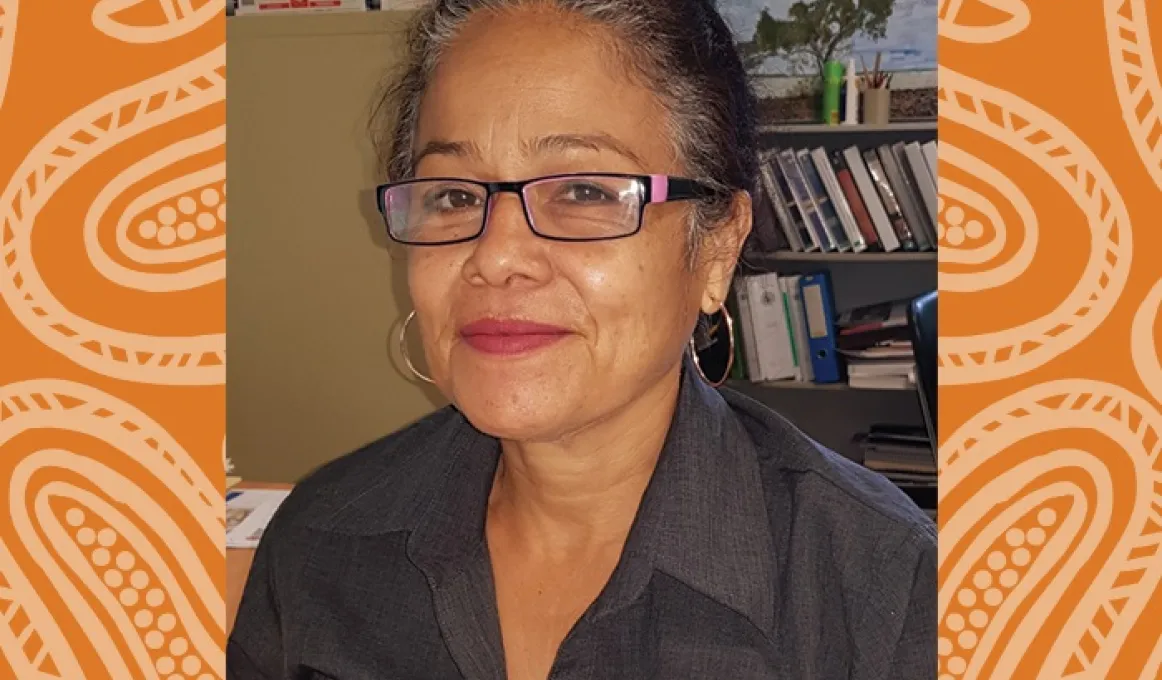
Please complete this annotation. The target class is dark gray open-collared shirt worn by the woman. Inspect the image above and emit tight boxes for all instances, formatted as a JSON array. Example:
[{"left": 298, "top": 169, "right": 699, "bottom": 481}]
[{"left": 227, "top": 371, "right": 937, "bottom": 680}]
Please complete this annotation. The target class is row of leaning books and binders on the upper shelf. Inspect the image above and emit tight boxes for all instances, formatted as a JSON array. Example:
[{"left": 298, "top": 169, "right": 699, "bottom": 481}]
[{"left": 755, "top": 141, "right": 939, "bottom": 252}]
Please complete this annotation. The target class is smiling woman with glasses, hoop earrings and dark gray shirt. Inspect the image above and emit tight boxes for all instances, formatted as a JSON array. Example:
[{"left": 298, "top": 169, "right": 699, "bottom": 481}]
[{"left": 228, "top": 0, "right": 937, "bottom": 680}]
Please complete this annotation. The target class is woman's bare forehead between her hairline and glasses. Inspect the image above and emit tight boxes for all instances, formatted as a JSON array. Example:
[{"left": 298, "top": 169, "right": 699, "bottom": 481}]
[{"left": 416, "top": 18, "right": 669, "bottom": 165}]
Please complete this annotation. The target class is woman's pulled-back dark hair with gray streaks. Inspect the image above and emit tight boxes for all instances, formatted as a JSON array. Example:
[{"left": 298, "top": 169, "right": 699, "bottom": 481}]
[{"left": 372, "top": 0, "right": 758, "bottom": 262}]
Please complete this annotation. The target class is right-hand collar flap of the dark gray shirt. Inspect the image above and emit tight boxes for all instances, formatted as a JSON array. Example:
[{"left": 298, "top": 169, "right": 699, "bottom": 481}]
[{"left": 597, "top": 360, "right": 776, "bottom": 634}]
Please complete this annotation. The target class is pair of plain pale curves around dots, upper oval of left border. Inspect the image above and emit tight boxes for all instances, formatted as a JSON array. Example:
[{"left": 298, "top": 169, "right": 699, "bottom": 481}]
[{"left": 84, "top": 126, "right": 225, "bottom": 293}]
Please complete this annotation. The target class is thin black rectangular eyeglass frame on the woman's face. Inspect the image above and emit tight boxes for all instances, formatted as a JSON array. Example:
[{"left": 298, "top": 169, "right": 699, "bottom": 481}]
[{"left": 375, "top": 172, "right": 720, "bottom": 246}]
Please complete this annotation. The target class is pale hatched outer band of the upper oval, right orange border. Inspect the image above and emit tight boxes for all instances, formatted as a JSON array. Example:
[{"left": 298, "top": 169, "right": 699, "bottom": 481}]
[{"left": 939, "top": 66, "right": 1132, "bottom": 385}]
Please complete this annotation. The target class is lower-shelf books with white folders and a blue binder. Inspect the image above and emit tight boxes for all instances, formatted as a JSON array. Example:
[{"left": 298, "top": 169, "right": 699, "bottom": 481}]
[{"left": 734, "top": 272, "right": 916, "bottom": 389}]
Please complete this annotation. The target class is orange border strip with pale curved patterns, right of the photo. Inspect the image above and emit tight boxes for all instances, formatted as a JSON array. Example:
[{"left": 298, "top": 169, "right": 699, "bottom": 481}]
[{"left": 938, "top": 0, "right": 1162, "bottom": 680}]
